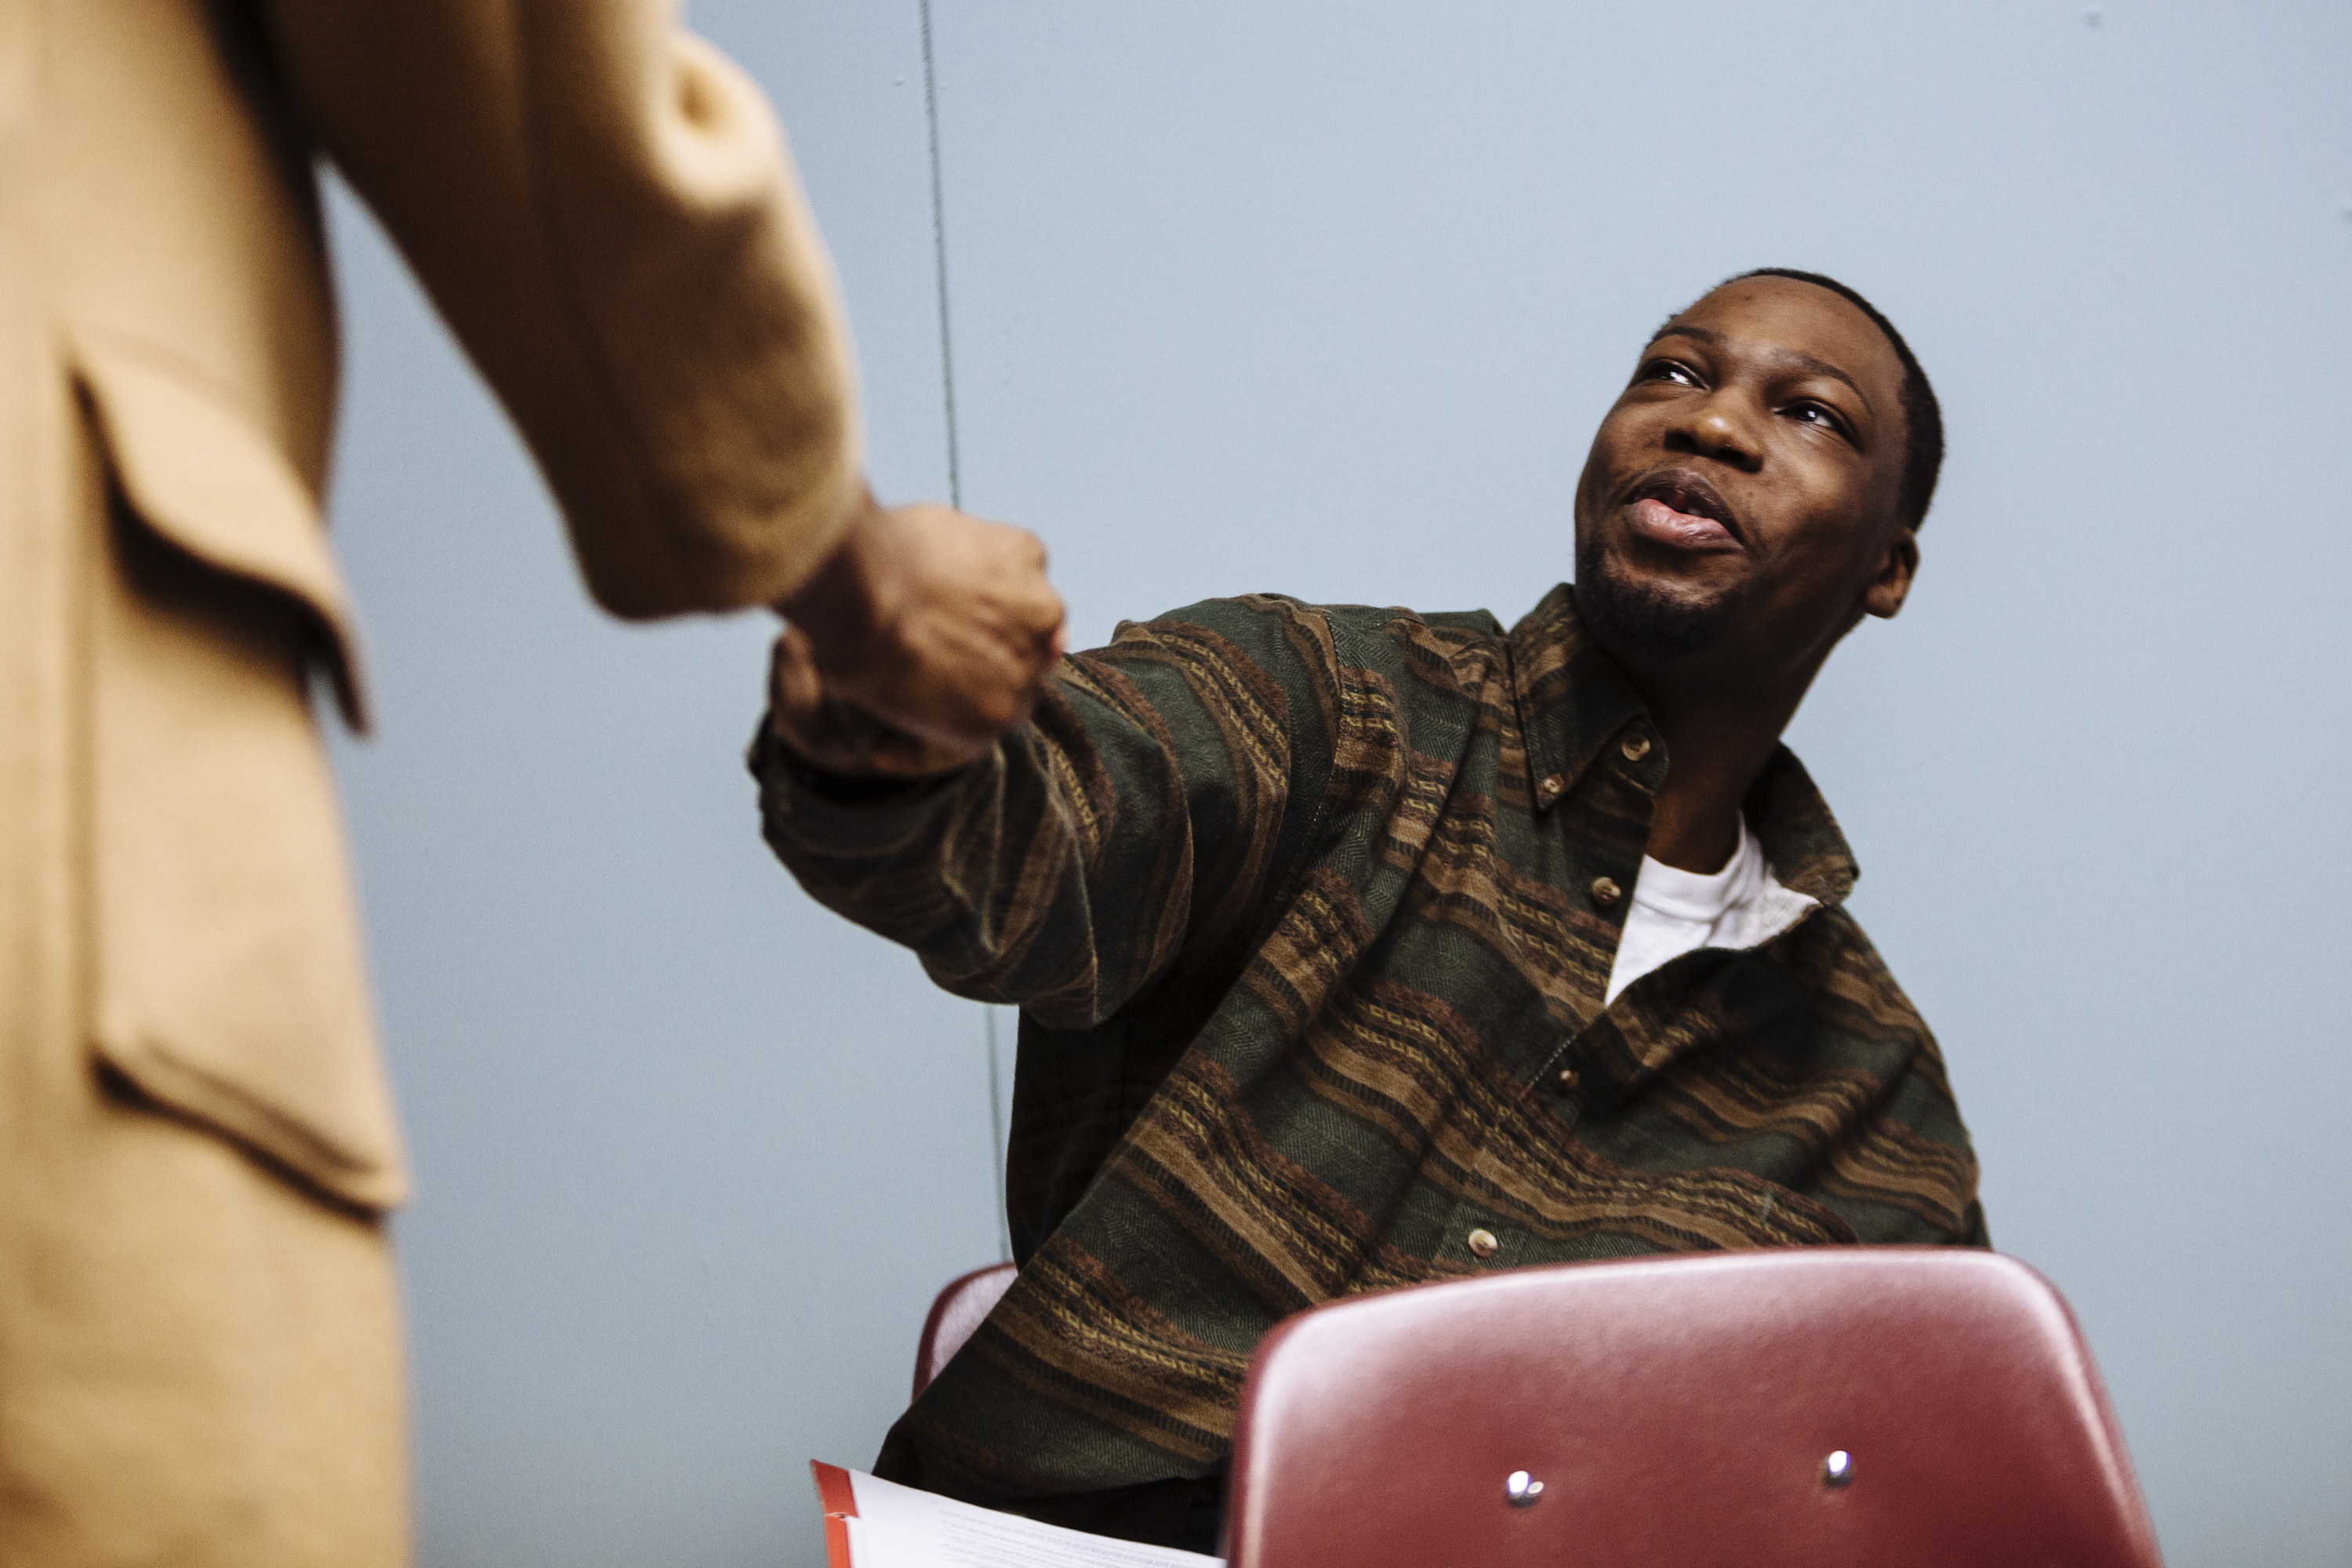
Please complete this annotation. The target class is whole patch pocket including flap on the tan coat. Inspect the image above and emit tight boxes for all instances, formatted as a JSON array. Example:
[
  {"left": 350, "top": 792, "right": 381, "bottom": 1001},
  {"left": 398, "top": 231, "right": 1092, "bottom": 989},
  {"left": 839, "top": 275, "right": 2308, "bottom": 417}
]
[{"left": 78, "top": 340, "right": 407, "bottom": 1208}]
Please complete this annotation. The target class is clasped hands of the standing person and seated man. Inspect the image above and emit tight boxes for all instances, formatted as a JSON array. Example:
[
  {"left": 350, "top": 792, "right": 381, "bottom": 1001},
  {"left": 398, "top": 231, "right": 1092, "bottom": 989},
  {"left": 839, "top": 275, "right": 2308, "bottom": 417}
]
[{"left": 769, "top": 503, "right": 1061, "bottom": 776}]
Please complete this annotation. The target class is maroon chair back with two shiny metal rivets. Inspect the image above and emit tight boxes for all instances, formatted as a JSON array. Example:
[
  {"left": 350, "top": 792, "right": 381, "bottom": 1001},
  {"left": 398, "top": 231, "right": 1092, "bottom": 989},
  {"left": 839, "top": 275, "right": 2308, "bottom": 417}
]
[{"left": 1225, "top": 1248, "right": 2161, "bottom": 1568}]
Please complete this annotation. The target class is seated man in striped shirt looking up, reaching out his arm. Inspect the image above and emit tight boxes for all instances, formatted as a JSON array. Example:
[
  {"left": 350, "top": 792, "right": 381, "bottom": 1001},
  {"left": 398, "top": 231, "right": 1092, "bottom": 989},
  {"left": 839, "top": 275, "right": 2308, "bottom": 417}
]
[{"left": 753, "top": 270, "right": 1985, "bottom": 1544}]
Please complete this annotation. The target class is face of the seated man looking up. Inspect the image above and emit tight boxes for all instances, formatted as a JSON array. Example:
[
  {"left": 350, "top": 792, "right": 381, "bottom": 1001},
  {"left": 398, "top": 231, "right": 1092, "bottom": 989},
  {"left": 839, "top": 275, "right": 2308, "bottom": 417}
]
[{"left": 1576, "top": 278, "right": 1919, "bottom": 684}]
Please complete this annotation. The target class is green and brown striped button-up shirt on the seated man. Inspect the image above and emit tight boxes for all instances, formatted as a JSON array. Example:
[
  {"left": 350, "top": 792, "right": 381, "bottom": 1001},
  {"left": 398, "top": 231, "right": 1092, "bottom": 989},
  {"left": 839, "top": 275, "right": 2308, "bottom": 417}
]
[{"left": 753, "top": 588, "right": 1985, "bottom": 1512}]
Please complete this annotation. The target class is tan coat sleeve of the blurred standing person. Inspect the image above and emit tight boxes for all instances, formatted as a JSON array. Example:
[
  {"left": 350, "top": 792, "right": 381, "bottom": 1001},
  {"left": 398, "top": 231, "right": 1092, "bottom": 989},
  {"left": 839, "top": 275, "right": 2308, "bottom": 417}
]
[{"left": 263, "top": 0, "right": 863, "bottom": 616}]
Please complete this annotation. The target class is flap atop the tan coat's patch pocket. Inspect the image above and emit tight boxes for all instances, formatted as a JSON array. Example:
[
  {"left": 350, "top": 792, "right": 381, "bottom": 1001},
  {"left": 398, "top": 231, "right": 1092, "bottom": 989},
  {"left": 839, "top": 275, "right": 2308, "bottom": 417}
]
[{"left": 73, "top": 339, "right": 367, "bottom": 729}]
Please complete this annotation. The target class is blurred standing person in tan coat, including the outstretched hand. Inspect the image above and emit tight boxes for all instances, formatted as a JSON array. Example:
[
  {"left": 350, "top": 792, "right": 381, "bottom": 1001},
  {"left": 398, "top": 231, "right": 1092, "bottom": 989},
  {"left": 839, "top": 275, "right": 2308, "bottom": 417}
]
[{"left": 0, "top": 0, "right": 1061, "bottom": 1568}]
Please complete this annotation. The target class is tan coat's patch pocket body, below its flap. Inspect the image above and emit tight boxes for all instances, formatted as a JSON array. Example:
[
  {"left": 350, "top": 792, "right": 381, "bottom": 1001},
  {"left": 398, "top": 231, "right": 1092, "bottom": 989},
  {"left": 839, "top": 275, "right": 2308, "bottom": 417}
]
[{"left": 89, "top": 601, "right": 407, "bottom": 1210}]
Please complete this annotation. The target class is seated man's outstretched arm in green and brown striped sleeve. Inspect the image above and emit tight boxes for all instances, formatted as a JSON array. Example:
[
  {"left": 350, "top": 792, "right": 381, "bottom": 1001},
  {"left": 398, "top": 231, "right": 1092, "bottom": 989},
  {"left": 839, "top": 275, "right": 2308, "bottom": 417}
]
[{"left": 753, "top": 600, "right": 1338, "bottom": 1027}]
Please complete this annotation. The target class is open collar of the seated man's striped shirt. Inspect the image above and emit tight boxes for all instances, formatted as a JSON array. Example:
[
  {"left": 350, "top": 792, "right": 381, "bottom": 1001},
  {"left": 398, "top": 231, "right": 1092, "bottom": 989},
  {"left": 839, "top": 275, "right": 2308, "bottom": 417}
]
[{"left": 1510, "top": 583, "right": 1860, "bottom": 905}]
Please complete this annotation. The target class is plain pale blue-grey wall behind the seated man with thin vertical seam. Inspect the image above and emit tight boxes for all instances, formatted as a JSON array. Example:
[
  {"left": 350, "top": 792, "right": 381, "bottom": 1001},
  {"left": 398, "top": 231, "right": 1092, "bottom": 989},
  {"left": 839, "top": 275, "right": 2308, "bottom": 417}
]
[{"left": 334, "top": 0, "right": 2352, "bottom": 1568}]
